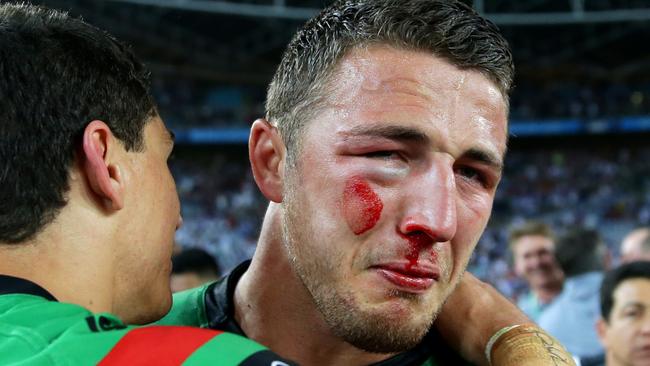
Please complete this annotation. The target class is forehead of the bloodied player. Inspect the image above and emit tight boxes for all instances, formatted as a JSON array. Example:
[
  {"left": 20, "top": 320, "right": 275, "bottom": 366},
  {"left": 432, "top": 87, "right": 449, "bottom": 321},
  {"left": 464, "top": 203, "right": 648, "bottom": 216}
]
[{"left": 318, "top": 46, "right": 507, "bottom": 157}]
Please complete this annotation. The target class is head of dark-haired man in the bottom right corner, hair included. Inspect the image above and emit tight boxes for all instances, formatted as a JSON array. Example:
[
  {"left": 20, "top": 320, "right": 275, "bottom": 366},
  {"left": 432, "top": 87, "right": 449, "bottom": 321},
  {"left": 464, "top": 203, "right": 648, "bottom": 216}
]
[{"left": 598, "top": 261, "right": 650, "bottom": 366}]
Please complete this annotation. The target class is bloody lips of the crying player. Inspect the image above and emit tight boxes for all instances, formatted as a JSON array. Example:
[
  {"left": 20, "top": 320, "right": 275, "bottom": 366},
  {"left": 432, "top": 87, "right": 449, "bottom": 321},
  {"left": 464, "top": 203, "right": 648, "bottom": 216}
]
[{"left": 372, "top": 263, "right": 440, "bottom": 293}]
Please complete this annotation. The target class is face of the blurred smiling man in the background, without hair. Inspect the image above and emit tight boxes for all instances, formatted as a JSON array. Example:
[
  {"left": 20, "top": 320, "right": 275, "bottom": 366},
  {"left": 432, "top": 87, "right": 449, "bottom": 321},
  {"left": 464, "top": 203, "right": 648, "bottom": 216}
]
[{"left": 513, "top": 235, "right": 562, "bottom": 289}]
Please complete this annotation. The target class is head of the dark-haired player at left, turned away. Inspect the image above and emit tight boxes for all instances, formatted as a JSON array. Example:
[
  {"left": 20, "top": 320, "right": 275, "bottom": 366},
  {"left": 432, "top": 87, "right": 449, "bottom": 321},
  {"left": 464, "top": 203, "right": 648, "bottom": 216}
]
[{"left": 0, "top": 4, "right": 180, "bottom": 323}]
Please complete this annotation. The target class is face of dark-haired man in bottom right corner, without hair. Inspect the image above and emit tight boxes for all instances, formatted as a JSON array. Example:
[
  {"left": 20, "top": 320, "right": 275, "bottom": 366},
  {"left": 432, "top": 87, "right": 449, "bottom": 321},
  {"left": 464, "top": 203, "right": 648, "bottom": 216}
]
[{"left": 598, "top": 278, "right": 650, "bottom": 366}]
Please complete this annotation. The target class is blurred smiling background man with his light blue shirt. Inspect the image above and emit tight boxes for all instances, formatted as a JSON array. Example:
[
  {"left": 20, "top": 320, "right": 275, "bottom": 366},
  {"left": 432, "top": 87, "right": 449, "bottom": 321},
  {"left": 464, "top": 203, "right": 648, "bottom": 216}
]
[{"left": 509, "top": 221, "right": 564, "bottom": 321}]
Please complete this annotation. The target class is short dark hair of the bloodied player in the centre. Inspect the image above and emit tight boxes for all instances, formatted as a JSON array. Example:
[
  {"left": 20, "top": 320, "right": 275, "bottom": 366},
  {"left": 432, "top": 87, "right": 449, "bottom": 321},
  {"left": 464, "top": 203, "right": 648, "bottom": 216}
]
[{"left": 266, "top": 0, "right": 514, "bottom": 158}]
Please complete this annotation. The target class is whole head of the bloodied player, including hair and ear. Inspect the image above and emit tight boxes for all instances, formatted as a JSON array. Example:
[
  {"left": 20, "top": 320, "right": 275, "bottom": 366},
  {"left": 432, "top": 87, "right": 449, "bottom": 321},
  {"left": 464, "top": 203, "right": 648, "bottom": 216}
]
[{"left": 250, "top": 0, "right": 513, "bottom": 353}]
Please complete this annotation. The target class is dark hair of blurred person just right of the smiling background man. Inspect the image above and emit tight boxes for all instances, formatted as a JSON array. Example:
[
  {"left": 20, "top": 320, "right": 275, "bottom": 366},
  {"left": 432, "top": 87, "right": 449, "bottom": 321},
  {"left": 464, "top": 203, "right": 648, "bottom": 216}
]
[{"left": 555, "top": 227, "right": 607, "bottom": 277}]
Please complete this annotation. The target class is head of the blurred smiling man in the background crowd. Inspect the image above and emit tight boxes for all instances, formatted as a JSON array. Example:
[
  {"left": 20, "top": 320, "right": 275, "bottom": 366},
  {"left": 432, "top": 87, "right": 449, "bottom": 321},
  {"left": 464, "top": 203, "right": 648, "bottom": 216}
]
[{"left": 509, "top": 221, "right": 563, "bottom": 290}]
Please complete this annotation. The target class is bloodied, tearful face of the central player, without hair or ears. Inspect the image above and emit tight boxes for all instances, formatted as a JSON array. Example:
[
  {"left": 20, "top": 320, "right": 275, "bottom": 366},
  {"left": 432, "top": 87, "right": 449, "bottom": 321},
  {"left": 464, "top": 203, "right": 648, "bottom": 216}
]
[{"left": 283, "top": 47, "right": 507, "bottom": 353}]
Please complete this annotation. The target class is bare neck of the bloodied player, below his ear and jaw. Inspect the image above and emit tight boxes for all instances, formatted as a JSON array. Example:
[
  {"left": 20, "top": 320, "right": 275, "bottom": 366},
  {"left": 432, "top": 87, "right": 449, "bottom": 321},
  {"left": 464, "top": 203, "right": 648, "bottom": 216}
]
[{"left": 235, "top": 204, "right": 390, "bottom": 365}]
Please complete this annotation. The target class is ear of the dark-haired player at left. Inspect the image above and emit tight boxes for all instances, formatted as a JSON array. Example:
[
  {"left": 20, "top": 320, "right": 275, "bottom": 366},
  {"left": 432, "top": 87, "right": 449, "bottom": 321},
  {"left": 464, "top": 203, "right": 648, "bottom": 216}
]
[{"left": 82, "top": 120, "right": 124, "bottom": 210}]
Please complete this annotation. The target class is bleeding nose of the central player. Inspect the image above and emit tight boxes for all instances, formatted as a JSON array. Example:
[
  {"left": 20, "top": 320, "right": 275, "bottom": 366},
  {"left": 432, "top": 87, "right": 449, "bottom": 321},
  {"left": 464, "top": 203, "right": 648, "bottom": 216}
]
[{"left": 399, "top": 160, "right": 457, "bottom": 242}]
